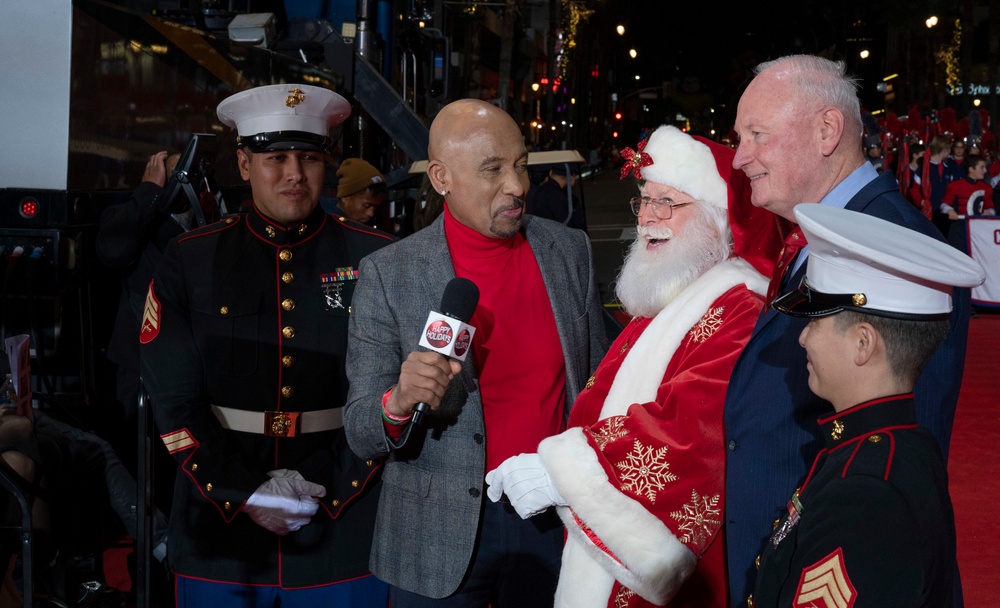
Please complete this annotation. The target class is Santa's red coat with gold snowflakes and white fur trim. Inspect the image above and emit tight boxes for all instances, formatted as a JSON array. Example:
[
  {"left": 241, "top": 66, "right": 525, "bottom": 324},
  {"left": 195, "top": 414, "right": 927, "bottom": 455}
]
[{"left": 538, "top": 258, "right": 767, "bottom": 608}]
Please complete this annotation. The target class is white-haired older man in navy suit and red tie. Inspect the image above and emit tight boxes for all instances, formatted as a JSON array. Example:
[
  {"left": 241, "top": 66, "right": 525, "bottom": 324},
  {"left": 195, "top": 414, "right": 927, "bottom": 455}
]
[{"left": 725, "top": 55, "right": 969, "bottom": 606}]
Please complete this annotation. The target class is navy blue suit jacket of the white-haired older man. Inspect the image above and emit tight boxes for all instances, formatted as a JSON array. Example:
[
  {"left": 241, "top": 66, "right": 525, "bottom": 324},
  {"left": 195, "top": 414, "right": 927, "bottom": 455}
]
[{"left": 725, "top": 172, "right": 970, "bottom": 606}]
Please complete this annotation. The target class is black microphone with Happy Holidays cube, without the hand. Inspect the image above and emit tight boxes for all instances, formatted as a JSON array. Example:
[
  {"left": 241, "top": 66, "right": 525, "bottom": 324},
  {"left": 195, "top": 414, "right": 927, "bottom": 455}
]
[{"left": 412, "top": 277, "right": 479, "bottom": 424}]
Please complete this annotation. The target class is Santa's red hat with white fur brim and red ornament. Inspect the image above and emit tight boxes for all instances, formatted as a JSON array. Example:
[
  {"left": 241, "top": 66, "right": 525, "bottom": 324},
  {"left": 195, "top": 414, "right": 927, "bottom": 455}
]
[{"left": 622, "top": 125, "right": 791, "bottom": 277}]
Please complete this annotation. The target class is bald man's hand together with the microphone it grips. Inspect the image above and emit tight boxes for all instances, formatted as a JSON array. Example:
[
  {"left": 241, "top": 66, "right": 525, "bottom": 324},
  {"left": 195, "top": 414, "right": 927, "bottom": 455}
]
[{"left": 386, "top": 278, "right": 479, "bottom": 424}]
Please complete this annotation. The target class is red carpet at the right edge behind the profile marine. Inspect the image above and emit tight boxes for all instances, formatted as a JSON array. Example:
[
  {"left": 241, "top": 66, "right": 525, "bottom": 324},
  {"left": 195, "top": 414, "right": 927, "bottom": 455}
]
[{"left": 948, "top": 314, "right": 1000, "bottom": 608}]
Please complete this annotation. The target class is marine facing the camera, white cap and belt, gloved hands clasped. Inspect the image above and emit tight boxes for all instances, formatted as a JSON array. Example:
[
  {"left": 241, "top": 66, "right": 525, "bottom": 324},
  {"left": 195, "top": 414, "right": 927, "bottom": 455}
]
[{"left": 139, "top": 84, "right": 393, "bottom": 608}]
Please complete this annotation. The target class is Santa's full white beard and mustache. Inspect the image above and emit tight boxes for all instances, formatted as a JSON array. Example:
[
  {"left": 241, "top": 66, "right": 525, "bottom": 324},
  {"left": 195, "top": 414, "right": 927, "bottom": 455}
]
[{"left": 615, "top": 205, "right": 730, "bottom": 318}]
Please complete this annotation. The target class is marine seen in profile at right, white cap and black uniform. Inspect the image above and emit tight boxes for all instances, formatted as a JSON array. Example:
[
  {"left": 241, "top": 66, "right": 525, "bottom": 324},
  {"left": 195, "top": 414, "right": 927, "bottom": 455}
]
[{"left": 749, "top": 204, "right": 985, "bottom": 608}]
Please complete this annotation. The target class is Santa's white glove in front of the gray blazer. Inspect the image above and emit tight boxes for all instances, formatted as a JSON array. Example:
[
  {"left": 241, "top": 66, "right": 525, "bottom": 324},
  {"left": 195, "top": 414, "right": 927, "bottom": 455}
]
[{"left": 486, "top": 454, "right": 566, "bottom": 519}]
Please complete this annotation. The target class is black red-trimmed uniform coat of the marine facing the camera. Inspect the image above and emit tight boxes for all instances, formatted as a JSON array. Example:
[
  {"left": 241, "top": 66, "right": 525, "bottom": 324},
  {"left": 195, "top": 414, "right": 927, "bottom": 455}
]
[{"left": 140, "top": 207, "right": 392, "bottom": 588}]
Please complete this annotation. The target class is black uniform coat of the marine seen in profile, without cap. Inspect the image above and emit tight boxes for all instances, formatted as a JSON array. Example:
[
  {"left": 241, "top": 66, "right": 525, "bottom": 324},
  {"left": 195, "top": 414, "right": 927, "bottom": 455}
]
[{"left": 752, "top": 394, "right": 955, "bottom": 608}]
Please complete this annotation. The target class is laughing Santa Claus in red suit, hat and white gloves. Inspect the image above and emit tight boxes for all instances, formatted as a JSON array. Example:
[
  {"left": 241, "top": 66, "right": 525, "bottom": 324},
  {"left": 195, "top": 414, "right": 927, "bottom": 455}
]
[{"left": 486, "top": 126, "right": 785, "bottom": 608}]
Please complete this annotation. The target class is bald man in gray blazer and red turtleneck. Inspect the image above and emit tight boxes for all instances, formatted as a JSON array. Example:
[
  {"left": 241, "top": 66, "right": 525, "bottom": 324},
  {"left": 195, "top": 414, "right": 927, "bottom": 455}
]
[{"left": 344, "top": 99, "right": 606, "bottom": 608}]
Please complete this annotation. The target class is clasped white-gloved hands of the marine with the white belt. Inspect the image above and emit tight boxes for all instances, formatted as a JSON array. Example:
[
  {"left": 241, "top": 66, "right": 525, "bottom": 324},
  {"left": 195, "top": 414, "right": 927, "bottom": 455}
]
[{"left": 243, "top": 469, "right": 326, "bottom": 536}]
